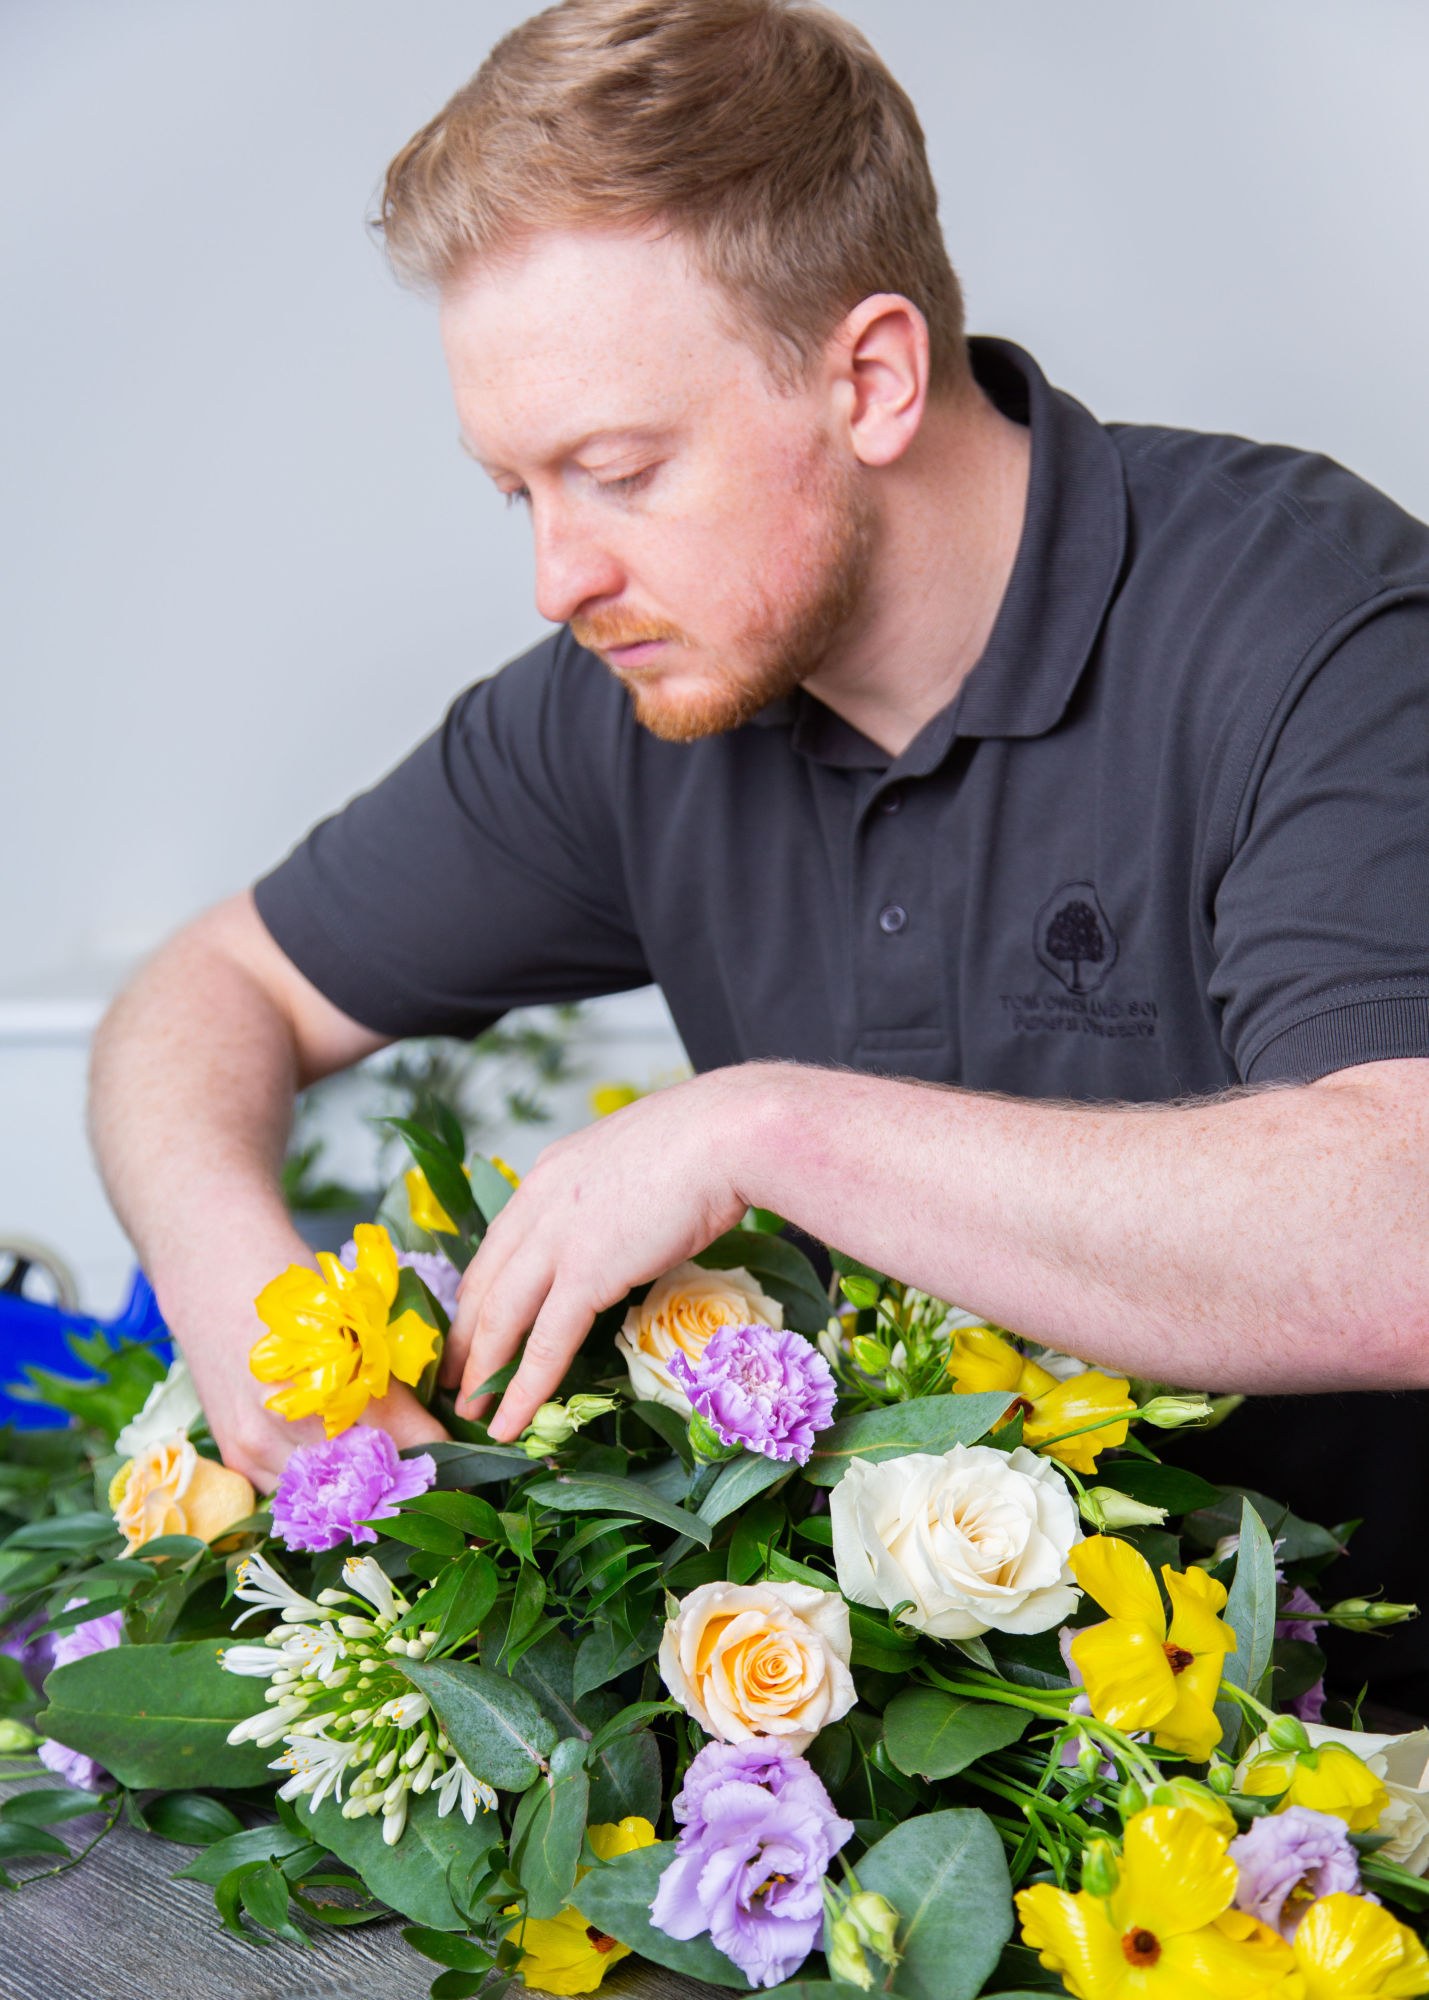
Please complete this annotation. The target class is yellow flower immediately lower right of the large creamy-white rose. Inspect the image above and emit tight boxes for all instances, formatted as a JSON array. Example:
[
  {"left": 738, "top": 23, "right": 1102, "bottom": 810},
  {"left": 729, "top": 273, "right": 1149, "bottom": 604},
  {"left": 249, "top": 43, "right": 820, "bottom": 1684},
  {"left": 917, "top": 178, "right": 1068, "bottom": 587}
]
[{"left": 1067, "top": 1534, "right": 1235, "bottom": 1764}]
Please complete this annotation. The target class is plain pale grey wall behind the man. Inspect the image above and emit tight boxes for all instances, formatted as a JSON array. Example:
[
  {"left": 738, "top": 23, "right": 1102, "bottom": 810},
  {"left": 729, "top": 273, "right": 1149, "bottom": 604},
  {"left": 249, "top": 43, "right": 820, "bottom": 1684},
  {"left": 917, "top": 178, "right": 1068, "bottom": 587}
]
[{"left": 0, "top": 0, "right": 1429, "bottom": 1312}]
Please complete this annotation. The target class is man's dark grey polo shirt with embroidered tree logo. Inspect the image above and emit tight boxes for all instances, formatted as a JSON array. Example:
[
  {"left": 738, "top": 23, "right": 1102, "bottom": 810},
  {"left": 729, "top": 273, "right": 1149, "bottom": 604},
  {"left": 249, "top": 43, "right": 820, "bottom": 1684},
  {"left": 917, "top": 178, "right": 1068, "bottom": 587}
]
[{"left": 256, "top": 340, "right": 1429, "bottom": 1704}]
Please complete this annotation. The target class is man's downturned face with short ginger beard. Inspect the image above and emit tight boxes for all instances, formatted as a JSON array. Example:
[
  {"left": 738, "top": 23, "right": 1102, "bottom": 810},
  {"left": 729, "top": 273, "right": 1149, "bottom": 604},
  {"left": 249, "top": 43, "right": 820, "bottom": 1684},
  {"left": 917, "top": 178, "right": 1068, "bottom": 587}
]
[{"left": 442, "top": 230, "right": 873, "bottom": 742}]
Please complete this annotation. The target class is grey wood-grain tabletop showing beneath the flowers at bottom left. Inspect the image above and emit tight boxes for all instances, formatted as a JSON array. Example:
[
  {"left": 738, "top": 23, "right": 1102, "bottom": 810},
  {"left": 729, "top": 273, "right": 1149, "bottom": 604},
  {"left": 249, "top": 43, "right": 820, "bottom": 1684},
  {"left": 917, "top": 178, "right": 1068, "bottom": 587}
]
[{"left": 0, "top": 1774, "right": 712, "bottom": 2000}]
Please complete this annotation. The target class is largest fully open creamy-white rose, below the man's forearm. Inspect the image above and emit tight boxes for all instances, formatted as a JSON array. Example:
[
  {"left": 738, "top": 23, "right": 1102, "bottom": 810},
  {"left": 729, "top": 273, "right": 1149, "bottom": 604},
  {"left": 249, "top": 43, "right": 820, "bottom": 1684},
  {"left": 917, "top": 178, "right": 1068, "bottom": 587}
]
[{"left": 829, "top": 1444, "right": 1081, "bottom": 1638}]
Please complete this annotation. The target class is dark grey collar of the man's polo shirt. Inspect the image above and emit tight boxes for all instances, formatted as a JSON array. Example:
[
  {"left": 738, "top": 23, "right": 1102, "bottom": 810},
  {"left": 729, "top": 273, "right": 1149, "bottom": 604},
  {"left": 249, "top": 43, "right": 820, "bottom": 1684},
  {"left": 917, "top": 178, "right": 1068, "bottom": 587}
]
[{"left": 755, "top": 338, "right": 1127, "bottom": 778}]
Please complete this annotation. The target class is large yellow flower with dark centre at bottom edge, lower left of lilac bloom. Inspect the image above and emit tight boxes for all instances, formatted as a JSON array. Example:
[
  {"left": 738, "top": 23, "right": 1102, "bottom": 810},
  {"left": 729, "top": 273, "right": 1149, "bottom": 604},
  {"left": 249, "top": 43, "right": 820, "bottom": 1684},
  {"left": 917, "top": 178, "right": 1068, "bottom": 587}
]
[{"left": 1017, "top": 1806, "right": 1293, "bottom": 2000}]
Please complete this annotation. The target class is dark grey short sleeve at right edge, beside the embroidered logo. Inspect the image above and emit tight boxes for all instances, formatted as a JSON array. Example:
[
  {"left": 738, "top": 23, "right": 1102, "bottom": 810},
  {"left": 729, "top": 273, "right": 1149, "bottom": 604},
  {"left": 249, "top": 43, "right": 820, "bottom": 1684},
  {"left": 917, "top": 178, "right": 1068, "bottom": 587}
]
[{"left": 1211, "top": 594, "right": 1429, "bottom": 1082}]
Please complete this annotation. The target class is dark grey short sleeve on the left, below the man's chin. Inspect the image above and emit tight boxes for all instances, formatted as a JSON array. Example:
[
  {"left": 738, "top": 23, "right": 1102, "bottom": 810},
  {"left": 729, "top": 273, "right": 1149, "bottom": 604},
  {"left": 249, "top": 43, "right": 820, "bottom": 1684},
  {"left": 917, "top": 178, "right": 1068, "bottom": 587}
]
[{"left": 254, "top": 632, "right": 650, "bottom": 1036}]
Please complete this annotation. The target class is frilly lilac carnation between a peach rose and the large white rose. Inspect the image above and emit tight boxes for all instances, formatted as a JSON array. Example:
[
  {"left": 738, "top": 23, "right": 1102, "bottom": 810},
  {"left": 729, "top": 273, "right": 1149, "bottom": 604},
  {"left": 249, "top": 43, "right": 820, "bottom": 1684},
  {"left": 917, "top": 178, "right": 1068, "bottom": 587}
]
[{"left": 668, "top": 1326, "right": 837, "bottom": 1466}]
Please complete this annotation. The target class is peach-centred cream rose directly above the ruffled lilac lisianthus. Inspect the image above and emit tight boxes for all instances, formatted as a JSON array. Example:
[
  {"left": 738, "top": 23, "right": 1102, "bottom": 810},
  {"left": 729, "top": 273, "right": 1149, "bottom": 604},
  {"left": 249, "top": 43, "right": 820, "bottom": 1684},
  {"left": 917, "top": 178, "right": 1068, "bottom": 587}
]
[{"left": 660, "top": 1584, "right": 857, "bottom": 1750}]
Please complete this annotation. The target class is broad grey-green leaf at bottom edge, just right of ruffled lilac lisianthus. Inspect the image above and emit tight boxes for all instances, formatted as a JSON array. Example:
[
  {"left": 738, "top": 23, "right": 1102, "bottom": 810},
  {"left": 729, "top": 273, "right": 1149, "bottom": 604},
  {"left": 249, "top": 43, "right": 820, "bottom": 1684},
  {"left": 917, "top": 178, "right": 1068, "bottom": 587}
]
[{"left": 844, "top": 1806, "right": 1013, "bottom": 2000}]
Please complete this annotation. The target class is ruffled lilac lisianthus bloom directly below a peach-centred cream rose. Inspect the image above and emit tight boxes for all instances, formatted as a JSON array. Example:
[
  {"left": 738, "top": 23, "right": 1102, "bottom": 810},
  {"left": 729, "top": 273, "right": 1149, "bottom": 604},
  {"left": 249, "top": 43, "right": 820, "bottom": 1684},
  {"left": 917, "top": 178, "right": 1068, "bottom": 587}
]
[{"left": 650, "top": 1742, "right": 853, "bottom": 1986}]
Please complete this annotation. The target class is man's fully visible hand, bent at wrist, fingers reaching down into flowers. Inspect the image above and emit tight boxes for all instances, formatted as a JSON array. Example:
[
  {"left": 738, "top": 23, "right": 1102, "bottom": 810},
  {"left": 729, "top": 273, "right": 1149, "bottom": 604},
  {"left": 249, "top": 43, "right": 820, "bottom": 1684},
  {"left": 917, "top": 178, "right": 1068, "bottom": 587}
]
[{"left": 442, "top": 1066, "right": 761, "bottom": 1440}]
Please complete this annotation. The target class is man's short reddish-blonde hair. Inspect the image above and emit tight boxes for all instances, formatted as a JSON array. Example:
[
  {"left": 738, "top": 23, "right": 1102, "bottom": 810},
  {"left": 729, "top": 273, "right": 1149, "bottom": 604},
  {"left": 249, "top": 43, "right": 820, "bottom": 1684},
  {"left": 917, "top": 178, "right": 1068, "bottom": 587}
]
[{"left": 376, "top": 0, "right": 969, "bottom": 392}]
